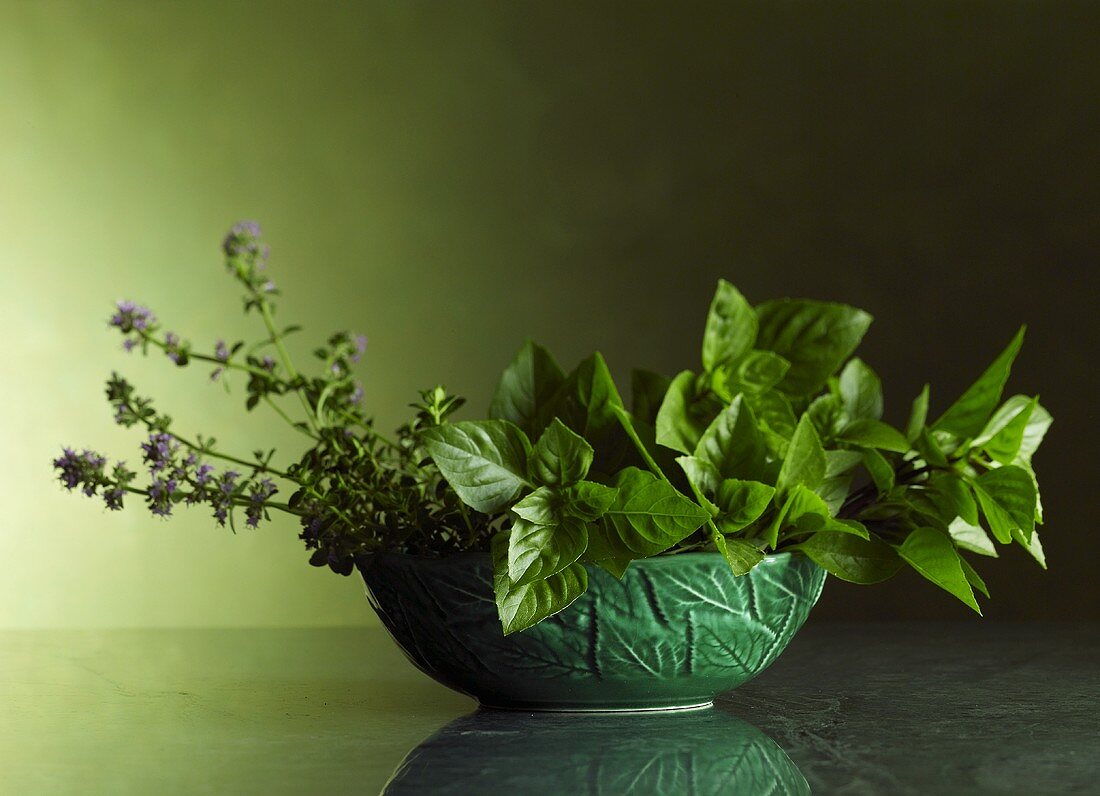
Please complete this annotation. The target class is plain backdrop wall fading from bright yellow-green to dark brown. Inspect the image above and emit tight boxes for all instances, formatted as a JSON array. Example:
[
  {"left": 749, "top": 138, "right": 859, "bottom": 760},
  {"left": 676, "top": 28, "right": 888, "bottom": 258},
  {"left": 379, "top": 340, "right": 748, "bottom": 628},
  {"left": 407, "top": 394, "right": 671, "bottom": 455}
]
[{"left": 0, "top": 0, "right": 1100, "bottom": 627}]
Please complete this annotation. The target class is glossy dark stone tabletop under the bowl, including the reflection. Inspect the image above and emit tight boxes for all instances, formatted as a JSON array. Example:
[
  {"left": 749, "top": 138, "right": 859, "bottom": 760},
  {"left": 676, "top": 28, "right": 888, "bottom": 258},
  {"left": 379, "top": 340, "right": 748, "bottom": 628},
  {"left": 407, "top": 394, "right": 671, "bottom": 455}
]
[{"left": 0, "top": 619, "right": 1100, "bottom": 796}]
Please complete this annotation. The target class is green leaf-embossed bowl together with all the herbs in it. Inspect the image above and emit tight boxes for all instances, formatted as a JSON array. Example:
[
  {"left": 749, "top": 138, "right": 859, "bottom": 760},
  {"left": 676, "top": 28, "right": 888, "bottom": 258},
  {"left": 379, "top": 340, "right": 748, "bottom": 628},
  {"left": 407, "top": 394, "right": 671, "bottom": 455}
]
[{"left": 54, "top": 223, "right": 1052, "bottom": 709}]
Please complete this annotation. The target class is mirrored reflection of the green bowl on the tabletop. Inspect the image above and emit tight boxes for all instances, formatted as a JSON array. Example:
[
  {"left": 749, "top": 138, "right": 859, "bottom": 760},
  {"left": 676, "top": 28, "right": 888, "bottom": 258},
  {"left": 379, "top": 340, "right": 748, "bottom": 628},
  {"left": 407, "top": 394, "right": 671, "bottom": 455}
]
[{"left": 384, "top": 708, "right": 810, "bottom": 796}]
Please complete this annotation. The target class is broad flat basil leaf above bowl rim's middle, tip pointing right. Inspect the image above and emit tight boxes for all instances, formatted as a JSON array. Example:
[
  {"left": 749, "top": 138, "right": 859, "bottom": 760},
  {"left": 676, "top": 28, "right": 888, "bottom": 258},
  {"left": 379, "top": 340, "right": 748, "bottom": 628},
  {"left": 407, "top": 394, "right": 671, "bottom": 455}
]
[{"left": 603, "top": 467, "right": 710, "bottom": 559}]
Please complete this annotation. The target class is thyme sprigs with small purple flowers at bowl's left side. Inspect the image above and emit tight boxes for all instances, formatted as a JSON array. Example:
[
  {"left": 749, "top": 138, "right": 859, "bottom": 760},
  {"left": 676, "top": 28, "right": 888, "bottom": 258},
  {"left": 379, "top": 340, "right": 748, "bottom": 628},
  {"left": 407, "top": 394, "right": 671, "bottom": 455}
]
[{"left": 54, "top": 222, "right": 494, "bottom": 575}]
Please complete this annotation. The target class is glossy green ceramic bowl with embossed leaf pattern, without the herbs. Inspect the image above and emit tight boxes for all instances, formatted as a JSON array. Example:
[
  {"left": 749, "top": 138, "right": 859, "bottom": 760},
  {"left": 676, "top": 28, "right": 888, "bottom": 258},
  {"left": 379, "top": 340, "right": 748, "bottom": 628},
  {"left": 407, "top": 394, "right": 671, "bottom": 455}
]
[{"left": 360, "top": 553, "right": 825, "bottom": 711}]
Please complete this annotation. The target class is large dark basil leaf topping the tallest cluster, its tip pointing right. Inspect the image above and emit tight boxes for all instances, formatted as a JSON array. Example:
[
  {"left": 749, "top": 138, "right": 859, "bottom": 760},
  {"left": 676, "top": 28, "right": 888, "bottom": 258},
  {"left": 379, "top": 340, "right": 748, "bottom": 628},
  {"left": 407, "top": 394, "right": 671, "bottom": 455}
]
[{"left": 757, "top": 299, "right": 871, "bottom": 396}]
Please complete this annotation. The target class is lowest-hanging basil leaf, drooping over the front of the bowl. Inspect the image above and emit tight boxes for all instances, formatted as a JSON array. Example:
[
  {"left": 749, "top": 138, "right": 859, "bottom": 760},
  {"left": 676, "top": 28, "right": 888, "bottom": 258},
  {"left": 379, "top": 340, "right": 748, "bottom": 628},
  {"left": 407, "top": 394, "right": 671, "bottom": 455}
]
[{"left": 492, "top": 533, "right": 589, "bottom": 635}]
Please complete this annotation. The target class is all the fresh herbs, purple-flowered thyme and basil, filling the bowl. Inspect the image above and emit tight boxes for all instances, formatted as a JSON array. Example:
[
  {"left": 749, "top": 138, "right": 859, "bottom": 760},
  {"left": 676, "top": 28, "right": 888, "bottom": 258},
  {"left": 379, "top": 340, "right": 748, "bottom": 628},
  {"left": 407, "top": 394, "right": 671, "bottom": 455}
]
[{"left": 54, "top": 223, "right": 1052, "bottom": 633}]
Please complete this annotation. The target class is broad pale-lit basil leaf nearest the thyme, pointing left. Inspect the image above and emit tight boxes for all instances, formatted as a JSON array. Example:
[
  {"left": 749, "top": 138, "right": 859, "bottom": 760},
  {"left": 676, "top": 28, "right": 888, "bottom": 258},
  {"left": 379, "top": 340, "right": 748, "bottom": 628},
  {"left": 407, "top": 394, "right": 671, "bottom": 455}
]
[{"left": 420, "top": 420, "right": 531, "bottom": 513}]
